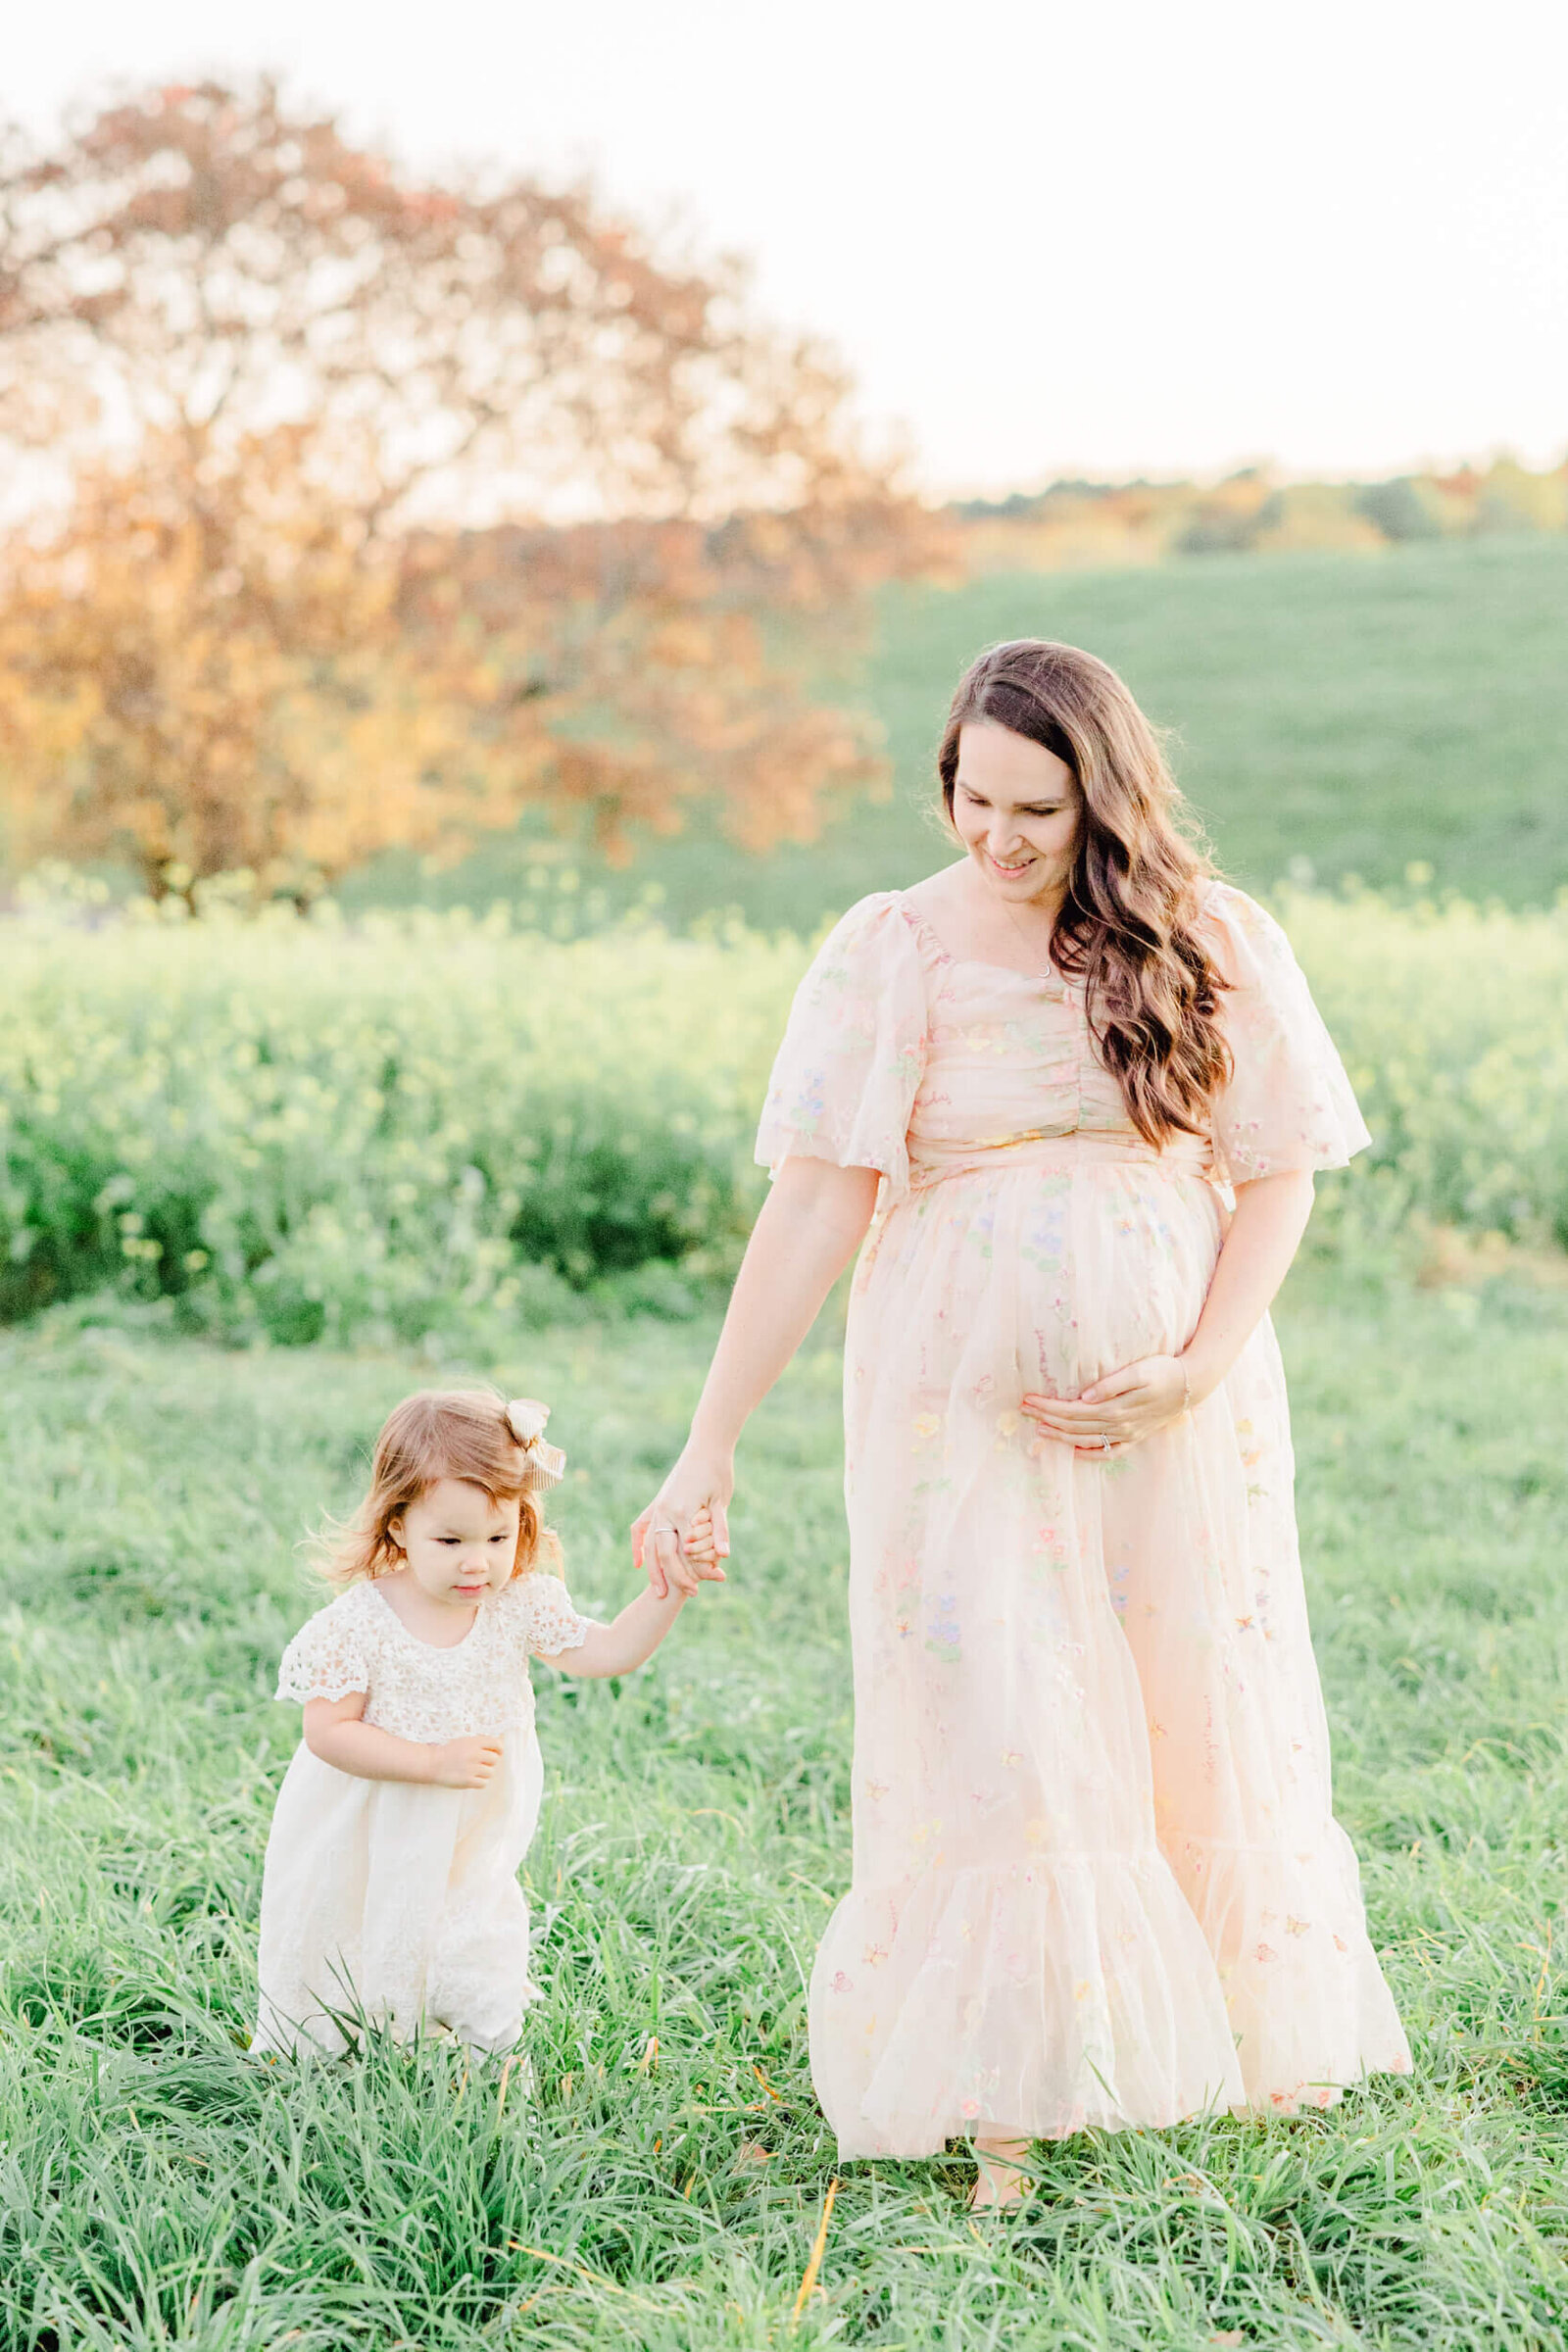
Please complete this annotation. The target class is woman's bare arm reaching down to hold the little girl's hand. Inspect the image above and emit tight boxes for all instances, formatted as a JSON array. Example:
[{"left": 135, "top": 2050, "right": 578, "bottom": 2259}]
[{"left": 632, "top": 1159, "right": 877, "bottom": 1599}]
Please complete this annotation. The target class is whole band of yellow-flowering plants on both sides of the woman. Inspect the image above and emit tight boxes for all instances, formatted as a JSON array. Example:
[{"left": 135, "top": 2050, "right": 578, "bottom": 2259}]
[{"left": 0, "top": 892, "right": 1568, "bottom": 1343}]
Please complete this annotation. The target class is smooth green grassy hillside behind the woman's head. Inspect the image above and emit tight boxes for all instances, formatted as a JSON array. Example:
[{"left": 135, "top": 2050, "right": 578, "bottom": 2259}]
[{"left": 343, "top": 536, "right": 1568, "bottom": 931}]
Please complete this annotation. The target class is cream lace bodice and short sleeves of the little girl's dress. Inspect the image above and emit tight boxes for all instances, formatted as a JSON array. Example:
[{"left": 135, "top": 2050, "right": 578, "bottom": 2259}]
[{"left": 277, "top": 1571, "right": 588, "bottom": 1740}]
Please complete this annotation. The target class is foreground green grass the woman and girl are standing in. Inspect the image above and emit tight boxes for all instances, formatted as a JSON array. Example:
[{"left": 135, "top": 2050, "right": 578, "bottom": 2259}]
[{"left": 0, "top": 1277, "right": 1568, "bottom": 2352}]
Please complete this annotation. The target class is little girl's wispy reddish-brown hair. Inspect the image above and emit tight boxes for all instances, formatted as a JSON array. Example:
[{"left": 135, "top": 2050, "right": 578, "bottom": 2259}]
[{"left": 318, "top": 1388, "right": 560, "bottom": 1586}]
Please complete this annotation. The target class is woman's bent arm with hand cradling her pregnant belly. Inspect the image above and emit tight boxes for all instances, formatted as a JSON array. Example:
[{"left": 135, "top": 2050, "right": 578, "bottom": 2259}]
[{"left": 1022, "top": 1169, "right": 1312, "bottom": 1453}]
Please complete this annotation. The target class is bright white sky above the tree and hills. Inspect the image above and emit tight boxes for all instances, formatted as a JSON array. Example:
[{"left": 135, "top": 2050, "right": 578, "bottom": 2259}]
[{"left": 12, "top": 0, "right": 1568, "bottom": 492}]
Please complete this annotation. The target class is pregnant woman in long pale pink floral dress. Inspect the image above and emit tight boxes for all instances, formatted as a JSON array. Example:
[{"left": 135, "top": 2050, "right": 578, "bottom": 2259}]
[{"left": 635, "top": 640, "right": 1410, "bottom": 2204}]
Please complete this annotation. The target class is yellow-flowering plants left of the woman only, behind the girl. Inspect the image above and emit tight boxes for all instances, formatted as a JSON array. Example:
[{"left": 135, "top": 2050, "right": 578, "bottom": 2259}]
[{"left": 0, "top": 915, "right": 792, "bottom": 1341}]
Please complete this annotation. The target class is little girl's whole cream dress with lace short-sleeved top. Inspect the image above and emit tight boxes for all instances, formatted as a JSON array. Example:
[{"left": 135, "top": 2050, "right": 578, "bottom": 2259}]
[{"left": 252, "top": 1571, "right": 588, "bottom": 2053}]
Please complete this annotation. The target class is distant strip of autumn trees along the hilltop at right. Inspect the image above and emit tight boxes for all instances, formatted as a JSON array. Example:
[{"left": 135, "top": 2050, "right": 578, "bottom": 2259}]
[{"left": 950, "top": 459, "right": 1568, "bottom": 571}]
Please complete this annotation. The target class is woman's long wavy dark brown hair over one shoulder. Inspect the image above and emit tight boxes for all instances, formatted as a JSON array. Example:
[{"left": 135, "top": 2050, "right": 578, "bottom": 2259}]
[{"left": 936, "top": 637, "right": 1232, "bottom": 1151}]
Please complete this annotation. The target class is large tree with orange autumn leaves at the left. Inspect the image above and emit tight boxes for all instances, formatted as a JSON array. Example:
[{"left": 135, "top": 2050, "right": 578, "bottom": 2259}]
[{"left": 0, "top": 82, "right": 933, "bottom": 896}]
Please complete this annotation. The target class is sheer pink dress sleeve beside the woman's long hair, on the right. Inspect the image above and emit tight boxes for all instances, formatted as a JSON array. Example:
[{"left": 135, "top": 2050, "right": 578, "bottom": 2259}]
[{"left": 1203, "top": 882, "right": 1373, "bottom": 1183}]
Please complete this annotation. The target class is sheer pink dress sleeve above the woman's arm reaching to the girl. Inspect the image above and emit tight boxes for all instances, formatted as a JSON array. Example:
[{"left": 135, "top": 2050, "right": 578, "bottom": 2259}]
[{"left": 757, "top": 892, "right": 926, "bottom": 1206}]
